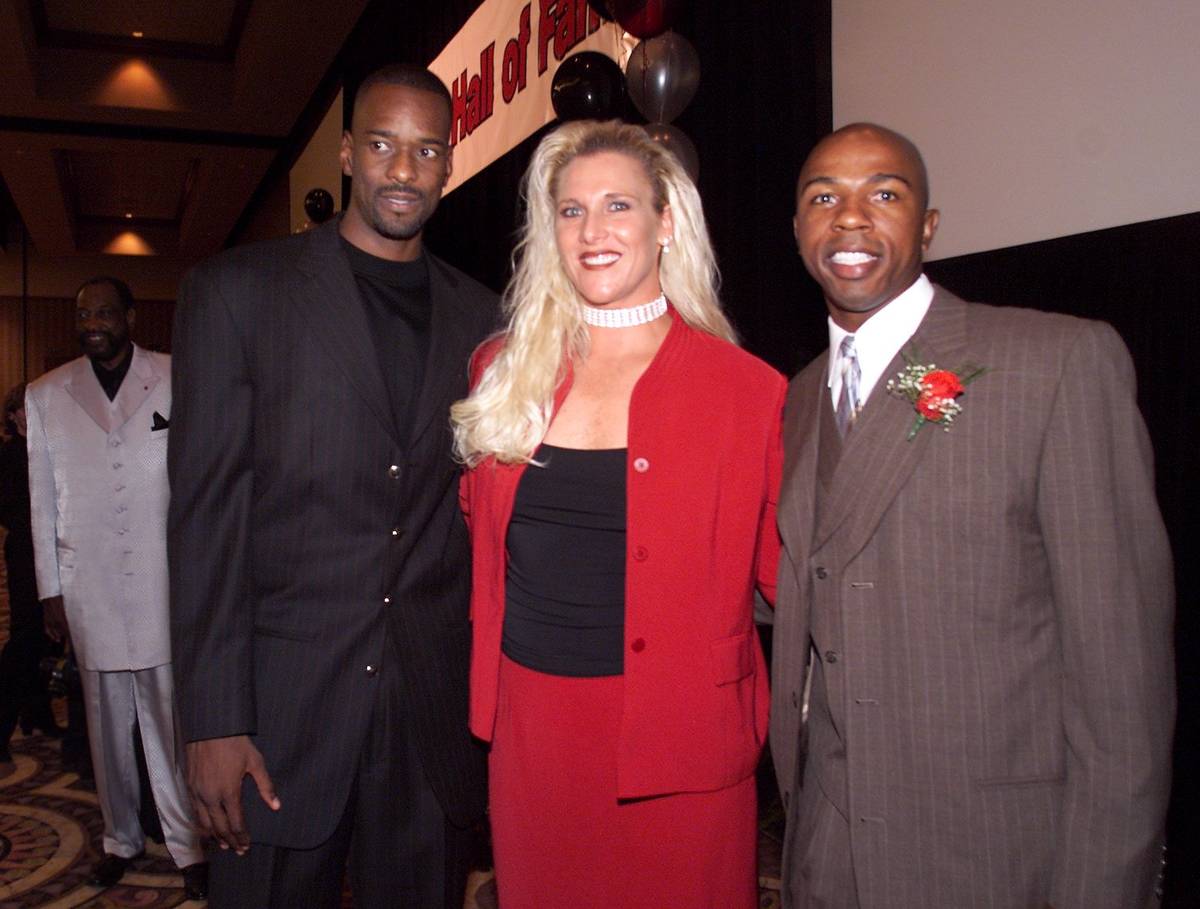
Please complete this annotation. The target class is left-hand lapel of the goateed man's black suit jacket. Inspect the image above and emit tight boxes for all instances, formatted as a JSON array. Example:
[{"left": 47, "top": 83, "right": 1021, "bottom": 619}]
[{"left": 292, "top": 219, "right": 402, "bottom": 444}]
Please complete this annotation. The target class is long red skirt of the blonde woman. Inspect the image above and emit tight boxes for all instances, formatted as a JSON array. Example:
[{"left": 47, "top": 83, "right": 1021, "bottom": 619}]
[{"left": 488, "top": 657, "right": 758, "bottom": 909}]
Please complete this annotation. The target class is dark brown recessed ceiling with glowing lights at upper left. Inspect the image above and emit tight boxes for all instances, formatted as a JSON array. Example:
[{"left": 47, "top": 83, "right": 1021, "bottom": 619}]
[{"left": 0, "top": 0, "right": 367, "bottom": 259}]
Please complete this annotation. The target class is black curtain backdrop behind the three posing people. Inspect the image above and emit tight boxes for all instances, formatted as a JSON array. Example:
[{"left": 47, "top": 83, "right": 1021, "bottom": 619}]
[{"left": 342, "top": 0, "right": 1200, "bottom": 909}]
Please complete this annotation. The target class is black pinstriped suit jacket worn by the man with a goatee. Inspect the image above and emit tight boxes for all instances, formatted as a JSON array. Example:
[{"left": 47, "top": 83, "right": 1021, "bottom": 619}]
[{"left": 169, "top": 222, "right": 496, "bottom": 848}]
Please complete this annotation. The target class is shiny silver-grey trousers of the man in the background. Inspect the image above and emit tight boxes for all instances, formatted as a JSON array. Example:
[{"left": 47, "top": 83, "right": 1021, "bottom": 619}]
[{"left": 79, "top": 663, "right": 204, "bottom": 868}]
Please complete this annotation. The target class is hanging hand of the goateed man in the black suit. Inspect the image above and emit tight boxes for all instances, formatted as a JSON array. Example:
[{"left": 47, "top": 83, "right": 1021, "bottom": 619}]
[{"left": 187, "top": 735, "right": 281, "bottom": 855}]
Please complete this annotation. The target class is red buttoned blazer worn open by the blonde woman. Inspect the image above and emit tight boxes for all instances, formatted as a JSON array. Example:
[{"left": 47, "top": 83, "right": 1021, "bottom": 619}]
[{"left": 461, "top": 311, "right": 786, "bottom": 797}]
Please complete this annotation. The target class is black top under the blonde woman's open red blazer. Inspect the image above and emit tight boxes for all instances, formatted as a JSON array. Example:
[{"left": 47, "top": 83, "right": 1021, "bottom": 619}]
[{"left": 502, "top": 445, "right": 625, "bottom": 676}]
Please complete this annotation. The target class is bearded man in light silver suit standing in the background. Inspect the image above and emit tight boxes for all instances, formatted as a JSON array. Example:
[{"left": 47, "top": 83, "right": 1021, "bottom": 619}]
[{"left": 25, "top": 277, "right": 208, "bottom": 899}]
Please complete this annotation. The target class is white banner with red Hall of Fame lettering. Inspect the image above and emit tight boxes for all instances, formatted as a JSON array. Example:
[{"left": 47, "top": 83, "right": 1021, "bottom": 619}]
[{"left": 430, "top": 0, "right": 629, "bottom": 192}]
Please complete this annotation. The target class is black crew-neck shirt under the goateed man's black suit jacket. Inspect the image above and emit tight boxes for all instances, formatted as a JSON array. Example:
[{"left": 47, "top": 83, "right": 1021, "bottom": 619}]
[{"left": 342, "top": 237, "right": 433, "bottom": 438}]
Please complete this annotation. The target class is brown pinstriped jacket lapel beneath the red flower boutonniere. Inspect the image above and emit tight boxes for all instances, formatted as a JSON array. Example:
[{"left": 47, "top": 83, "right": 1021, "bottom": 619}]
[{"left": 814, "top": 288, "right": 967, "bottom": 558}]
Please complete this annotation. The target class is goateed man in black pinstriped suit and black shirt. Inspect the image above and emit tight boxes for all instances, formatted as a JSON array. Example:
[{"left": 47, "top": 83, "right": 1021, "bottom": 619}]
[{"left": 169, "top": 66, "right": 496, "bottom": 909}]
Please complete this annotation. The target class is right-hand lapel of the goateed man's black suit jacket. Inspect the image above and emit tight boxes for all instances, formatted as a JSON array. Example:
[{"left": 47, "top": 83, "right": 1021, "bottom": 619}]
[{"left": 409, "top": 253, "right": 475, "bottom": 446}]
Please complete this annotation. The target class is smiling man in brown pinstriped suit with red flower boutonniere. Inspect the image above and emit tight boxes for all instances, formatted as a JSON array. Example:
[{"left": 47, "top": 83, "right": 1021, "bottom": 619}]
[{"left": 770, "top": 124, "right": 1175, "bottom": 909}]
